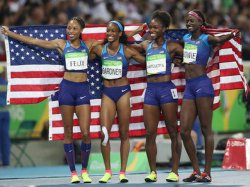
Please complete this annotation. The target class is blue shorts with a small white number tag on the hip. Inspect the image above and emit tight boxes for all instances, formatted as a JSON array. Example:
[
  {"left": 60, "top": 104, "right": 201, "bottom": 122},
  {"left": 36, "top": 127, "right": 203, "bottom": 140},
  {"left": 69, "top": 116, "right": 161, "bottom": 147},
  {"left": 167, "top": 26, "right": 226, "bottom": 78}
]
[{"left": 144, "top": 81, "right": 178, "bottom": 106}]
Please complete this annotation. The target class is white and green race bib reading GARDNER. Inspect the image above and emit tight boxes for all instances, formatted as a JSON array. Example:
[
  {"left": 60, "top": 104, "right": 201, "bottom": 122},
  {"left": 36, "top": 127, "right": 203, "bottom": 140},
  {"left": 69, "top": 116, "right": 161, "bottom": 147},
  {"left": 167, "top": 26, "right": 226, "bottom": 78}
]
[{"left": 102, "top": 60, "right": 122, "bottom": 79}]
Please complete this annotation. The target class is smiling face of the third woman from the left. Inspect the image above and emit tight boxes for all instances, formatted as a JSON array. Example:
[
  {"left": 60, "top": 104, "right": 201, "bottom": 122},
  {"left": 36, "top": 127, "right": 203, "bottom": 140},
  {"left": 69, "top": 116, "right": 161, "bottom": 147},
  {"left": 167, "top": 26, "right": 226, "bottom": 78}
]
[{"left": 149, "top": 19, "right": 166, "bottom": 40}]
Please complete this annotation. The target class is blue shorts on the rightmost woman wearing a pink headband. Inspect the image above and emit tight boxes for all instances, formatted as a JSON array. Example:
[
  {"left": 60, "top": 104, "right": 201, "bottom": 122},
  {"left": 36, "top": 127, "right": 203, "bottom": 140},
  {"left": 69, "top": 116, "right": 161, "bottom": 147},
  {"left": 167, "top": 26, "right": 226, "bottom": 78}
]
[{"left": 183, "top": 75, "right": 214, "bottom": 100}]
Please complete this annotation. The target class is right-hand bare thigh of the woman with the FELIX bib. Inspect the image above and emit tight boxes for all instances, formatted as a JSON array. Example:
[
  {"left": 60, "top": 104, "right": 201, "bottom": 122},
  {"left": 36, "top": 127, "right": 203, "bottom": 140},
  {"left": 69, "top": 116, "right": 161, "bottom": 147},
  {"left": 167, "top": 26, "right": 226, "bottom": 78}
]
[{"left": 75, "top": 104, "right": 90, "bottom": 132}]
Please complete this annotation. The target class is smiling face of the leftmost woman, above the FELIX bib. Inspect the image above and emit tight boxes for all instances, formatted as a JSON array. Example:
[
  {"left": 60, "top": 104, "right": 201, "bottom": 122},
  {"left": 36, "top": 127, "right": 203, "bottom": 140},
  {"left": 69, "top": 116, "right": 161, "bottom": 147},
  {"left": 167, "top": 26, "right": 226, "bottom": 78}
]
[{"left": 67, "top": 20, "right": 83, "bottom": 41}]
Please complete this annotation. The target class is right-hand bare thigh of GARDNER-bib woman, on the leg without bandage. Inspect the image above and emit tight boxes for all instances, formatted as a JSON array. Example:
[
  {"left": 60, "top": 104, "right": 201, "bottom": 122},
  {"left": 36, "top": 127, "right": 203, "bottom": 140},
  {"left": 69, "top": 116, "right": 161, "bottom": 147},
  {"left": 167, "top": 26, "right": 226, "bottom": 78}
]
[{"left": 116, "top": 92, "right": 131, "bottom": 132}]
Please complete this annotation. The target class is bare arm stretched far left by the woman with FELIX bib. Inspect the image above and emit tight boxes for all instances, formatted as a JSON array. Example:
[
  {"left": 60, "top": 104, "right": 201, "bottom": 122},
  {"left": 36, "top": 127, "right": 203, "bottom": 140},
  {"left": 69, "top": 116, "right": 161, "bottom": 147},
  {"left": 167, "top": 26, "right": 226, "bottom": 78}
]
[{"left": 1, "top": 26, "right": 65, "bottom": 53}]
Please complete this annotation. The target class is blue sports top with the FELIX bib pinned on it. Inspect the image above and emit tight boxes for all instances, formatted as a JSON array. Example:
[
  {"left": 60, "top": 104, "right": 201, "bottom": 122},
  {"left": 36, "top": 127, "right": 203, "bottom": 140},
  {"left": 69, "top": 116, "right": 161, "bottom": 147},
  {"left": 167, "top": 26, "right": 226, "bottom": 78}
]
[{"left": 63, "top": 41, "right": 89, "bottom": 73}]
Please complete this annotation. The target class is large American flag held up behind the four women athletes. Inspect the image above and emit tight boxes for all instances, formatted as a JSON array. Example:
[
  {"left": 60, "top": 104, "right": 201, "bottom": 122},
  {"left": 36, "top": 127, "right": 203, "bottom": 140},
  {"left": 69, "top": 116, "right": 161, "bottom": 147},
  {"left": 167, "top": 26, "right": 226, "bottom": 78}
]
[{"left": 6, "top": 25, "right": 246, "bottom": 140}]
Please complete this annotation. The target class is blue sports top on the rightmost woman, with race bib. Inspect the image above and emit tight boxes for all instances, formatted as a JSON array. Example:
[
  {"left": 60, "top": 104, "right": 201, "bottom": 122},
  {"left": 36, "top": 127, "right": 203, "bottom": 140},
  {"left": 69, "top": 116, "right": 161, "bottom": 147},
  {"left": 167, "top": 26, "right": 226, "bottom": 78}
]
[{"left": 183, "top": 33, "right": 213, "bottom": 66}]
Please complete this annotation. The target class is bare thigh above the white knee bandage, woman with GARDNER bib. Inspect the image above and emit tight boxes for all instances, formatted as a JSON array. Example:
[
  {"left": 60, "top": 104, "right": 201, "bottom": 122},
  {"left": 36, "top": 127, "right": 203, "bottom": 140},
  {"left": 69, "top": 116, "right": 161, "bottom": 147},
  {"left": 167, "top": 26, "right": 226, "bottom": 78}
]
[{"left": 100, "top": 94, "right": 116, "bottom": 132}]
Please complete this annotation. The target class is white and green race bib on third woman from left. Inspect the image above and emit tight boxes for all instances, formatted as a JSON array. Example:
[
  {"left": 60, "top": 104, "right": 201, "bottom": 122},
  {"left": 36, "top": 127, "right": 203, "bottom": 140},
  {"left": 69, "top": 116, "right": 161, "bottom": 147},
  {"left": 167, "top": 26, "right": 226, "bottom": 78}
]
[{"left": 146, "top": 54, "right": 166, "bottom": 75}]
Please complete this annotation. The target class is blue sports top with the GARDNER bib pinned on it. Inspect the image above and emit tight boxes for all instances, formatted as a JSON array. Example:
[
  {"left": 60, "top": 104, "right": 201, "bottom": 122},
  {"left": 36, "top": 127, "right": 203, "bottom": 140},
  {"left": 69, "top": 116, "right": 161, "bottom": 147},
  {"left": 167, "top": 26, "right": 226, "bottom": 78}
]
[{"left": 101, "top": 43, "right": 129, "bottom": 79}]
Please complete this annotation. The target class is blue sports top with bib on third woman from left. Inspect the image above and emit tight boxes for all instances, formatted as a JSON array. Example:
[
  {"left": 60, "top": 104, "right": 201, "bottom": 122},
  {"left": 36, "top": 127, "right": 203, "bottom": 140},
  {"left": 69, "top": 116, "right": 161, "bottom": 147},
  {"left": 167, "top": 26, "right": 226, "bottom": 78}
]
[{"left": 146, "top": 40, "right": 173, "bottom": 76}]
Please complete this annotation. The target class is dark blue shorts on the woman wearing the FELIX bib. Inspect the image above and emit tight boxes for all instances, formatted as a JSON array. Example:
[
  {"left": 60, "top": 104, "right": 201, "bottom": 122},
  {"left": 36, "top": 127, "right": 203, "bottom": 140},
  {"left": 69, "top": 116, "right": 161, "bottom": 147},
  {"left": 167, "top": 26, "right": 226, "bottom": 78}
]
[{"left": 58, "top": 79, "right": 90, "bottom": 106}]
